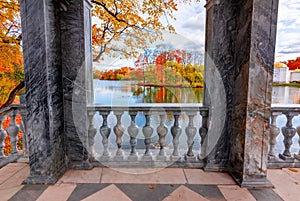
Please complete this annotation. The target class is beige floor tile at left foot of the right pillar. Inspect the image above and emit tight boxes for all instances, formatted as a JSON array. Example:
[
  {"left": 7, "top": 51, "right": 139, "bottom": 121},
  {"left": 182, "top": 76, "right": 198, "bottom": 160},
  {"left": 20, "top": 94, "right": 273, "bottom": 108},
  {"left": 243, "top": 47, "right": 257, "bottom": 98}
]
[{"left": 184, "top": 169, "right": 235, "bottom": 185}]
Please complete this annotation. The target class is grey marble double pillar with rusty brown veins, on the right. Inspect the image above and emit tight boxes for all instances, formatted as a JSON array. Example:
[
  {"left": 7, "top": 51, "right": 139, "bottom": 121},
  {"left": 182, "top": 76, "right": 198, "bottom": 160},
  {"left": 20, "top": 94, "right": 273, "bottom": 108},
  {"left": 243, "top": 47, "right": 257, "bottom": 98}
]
[{"left": 205, "top": 0, "right": 278, "bottom": 187}]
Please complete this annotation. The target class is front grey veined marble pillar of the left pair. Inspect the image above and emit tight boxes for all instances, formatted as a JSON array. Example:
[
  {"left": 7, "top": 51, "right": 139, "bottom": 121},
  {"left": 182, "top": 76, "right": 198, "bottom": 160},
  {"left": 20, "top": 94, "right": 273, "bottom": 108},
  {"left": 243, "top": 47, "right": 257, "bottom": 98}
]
[{"left": 21, "top": 0, "right": 66, "bottom": 183}]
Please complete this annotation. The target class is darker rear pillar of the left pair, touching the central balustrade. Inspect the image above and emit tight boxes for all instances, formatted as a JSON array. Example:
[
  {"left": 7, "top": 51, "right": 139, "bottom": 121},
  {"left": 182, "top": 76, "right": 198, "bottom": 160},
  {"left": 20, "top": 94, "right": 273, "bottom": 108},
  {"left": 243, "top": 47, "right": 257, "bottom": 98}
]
[{"left": 60, "top": 0, "right": 93, "bottom": 169}]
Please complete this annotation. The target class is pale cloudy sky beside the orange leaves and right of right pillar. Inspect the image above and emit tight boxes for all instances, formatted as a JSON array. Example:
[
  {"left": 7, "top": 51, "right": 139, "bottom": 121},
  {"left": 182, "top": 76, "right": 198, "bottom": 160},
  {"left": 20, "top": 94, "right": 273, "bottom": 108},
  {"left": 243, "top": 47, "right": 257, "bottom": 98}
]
[{"left": 94, "top": 0, "right": 300, "bottom": 69}]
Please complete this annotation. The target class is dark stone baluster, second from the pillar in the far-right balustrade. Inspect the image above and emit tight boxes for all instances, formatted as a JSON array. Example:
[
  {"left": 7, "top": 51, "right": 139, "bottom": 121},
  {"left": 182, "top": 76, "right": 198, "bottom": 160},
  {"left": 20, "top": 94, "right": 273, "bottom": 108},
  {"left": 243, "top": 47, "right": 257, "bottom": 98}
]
[{"left": 279, "top": 112, "right": 297, "bottom": 161}]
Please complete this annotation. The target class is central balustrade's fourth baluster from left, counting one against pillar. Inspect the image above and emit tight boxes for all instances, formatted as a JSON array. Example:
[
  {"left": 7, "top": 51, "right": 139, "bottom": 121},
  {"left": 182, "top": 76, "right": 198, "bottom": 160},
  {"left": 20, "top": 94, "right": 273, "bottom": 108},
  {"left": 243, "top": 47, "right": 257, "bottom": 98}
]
[{"left": 127, "top": 111, "right": 139, "bottom": 160}]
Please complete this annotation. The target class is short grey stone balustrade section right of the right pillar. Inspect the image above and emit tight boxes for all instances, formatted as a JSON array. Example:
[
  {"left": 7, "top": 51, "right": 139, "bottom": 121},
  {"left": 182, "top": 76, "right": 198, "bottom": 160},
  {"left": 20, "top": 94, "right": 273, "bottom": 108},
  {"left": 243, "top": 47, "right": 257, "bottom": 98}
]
[{"left": 268, "top": 107, "right": 300, "bottom": 168}]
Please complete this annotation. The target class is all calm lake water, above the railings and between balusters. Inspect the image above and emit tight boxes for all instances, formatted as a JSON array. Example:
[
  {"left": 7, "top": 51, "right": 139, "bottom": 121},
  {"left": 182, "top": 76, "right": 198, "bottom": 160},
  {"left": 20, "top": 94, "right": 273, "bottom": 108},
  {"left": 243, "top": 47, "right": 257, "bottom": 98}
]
[{"left": 94, "top": 80, "right": 300, "bottom": 153}]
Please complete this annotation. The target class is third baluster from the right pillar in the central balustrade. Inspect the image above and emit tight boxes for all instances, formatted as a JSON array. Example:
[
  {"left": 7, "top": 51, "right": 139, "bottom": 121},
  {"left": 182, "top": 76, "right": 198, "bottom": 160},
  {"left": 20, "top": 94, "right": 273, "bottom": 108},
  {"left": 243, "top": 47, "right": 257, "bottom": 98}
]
[{"left": 171, "top": 112, "right": 182, "bottom": 161}]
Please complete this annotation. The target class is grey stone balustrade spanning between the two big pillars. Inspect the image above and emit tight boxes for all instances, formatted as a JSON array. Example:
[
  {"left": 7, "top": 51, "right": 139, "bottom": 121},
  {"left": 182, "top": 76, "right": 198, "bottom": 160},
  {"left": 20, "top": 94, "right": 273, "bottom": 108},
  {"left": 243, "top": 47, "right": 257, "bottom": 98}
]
[{"left": 88, "top": 106, "right": 208, "bottom": 166}]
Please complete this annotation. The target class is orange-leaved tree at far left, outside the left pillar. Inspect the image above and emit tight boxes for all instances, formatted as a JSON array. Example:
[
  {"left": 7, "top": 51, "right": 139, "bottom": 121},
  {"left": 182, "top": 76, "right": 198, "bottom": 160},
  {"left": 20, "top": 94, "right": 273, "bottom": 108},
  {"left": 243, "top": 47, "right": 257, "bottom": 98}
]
[{"left": 0, "top": 0, "right": 24, "bottom": 108}]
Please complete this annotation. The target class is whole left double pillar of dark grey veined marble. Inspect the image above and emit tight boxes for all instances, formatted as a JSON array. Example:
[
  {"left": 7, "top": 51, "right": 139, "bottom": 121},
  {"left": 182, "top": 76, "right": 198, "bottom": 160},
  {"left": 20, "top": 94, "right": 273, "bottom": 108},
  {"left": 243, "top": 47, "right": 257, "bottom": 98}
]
[{"left": 21, "top": 0, "right": 92, "bottom": 184}]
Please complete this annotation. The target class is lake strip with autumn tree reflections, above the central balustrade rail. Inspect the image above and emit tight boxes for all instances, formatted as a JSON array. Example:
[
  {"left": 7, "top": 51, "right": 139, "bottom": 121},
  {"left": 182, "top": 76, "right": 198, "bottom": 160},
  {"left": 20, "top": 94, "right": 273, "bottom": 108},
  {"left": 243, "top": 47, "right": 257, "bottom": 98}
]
[{"left": 94, "top": 80, "right": 203, "bottom": 105}]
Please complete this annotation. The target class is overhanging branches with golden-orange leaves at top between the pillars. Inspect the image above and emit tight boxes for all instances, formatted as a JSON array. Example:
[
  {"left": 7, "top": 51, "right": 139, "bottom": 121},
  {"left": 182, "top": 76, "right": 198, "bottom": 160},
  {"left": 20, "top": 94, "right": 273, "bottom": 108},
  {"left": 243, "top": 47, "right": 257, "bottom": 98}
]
[{"left": 91, "top": 0, "right": 200, "bottom": 61}]
